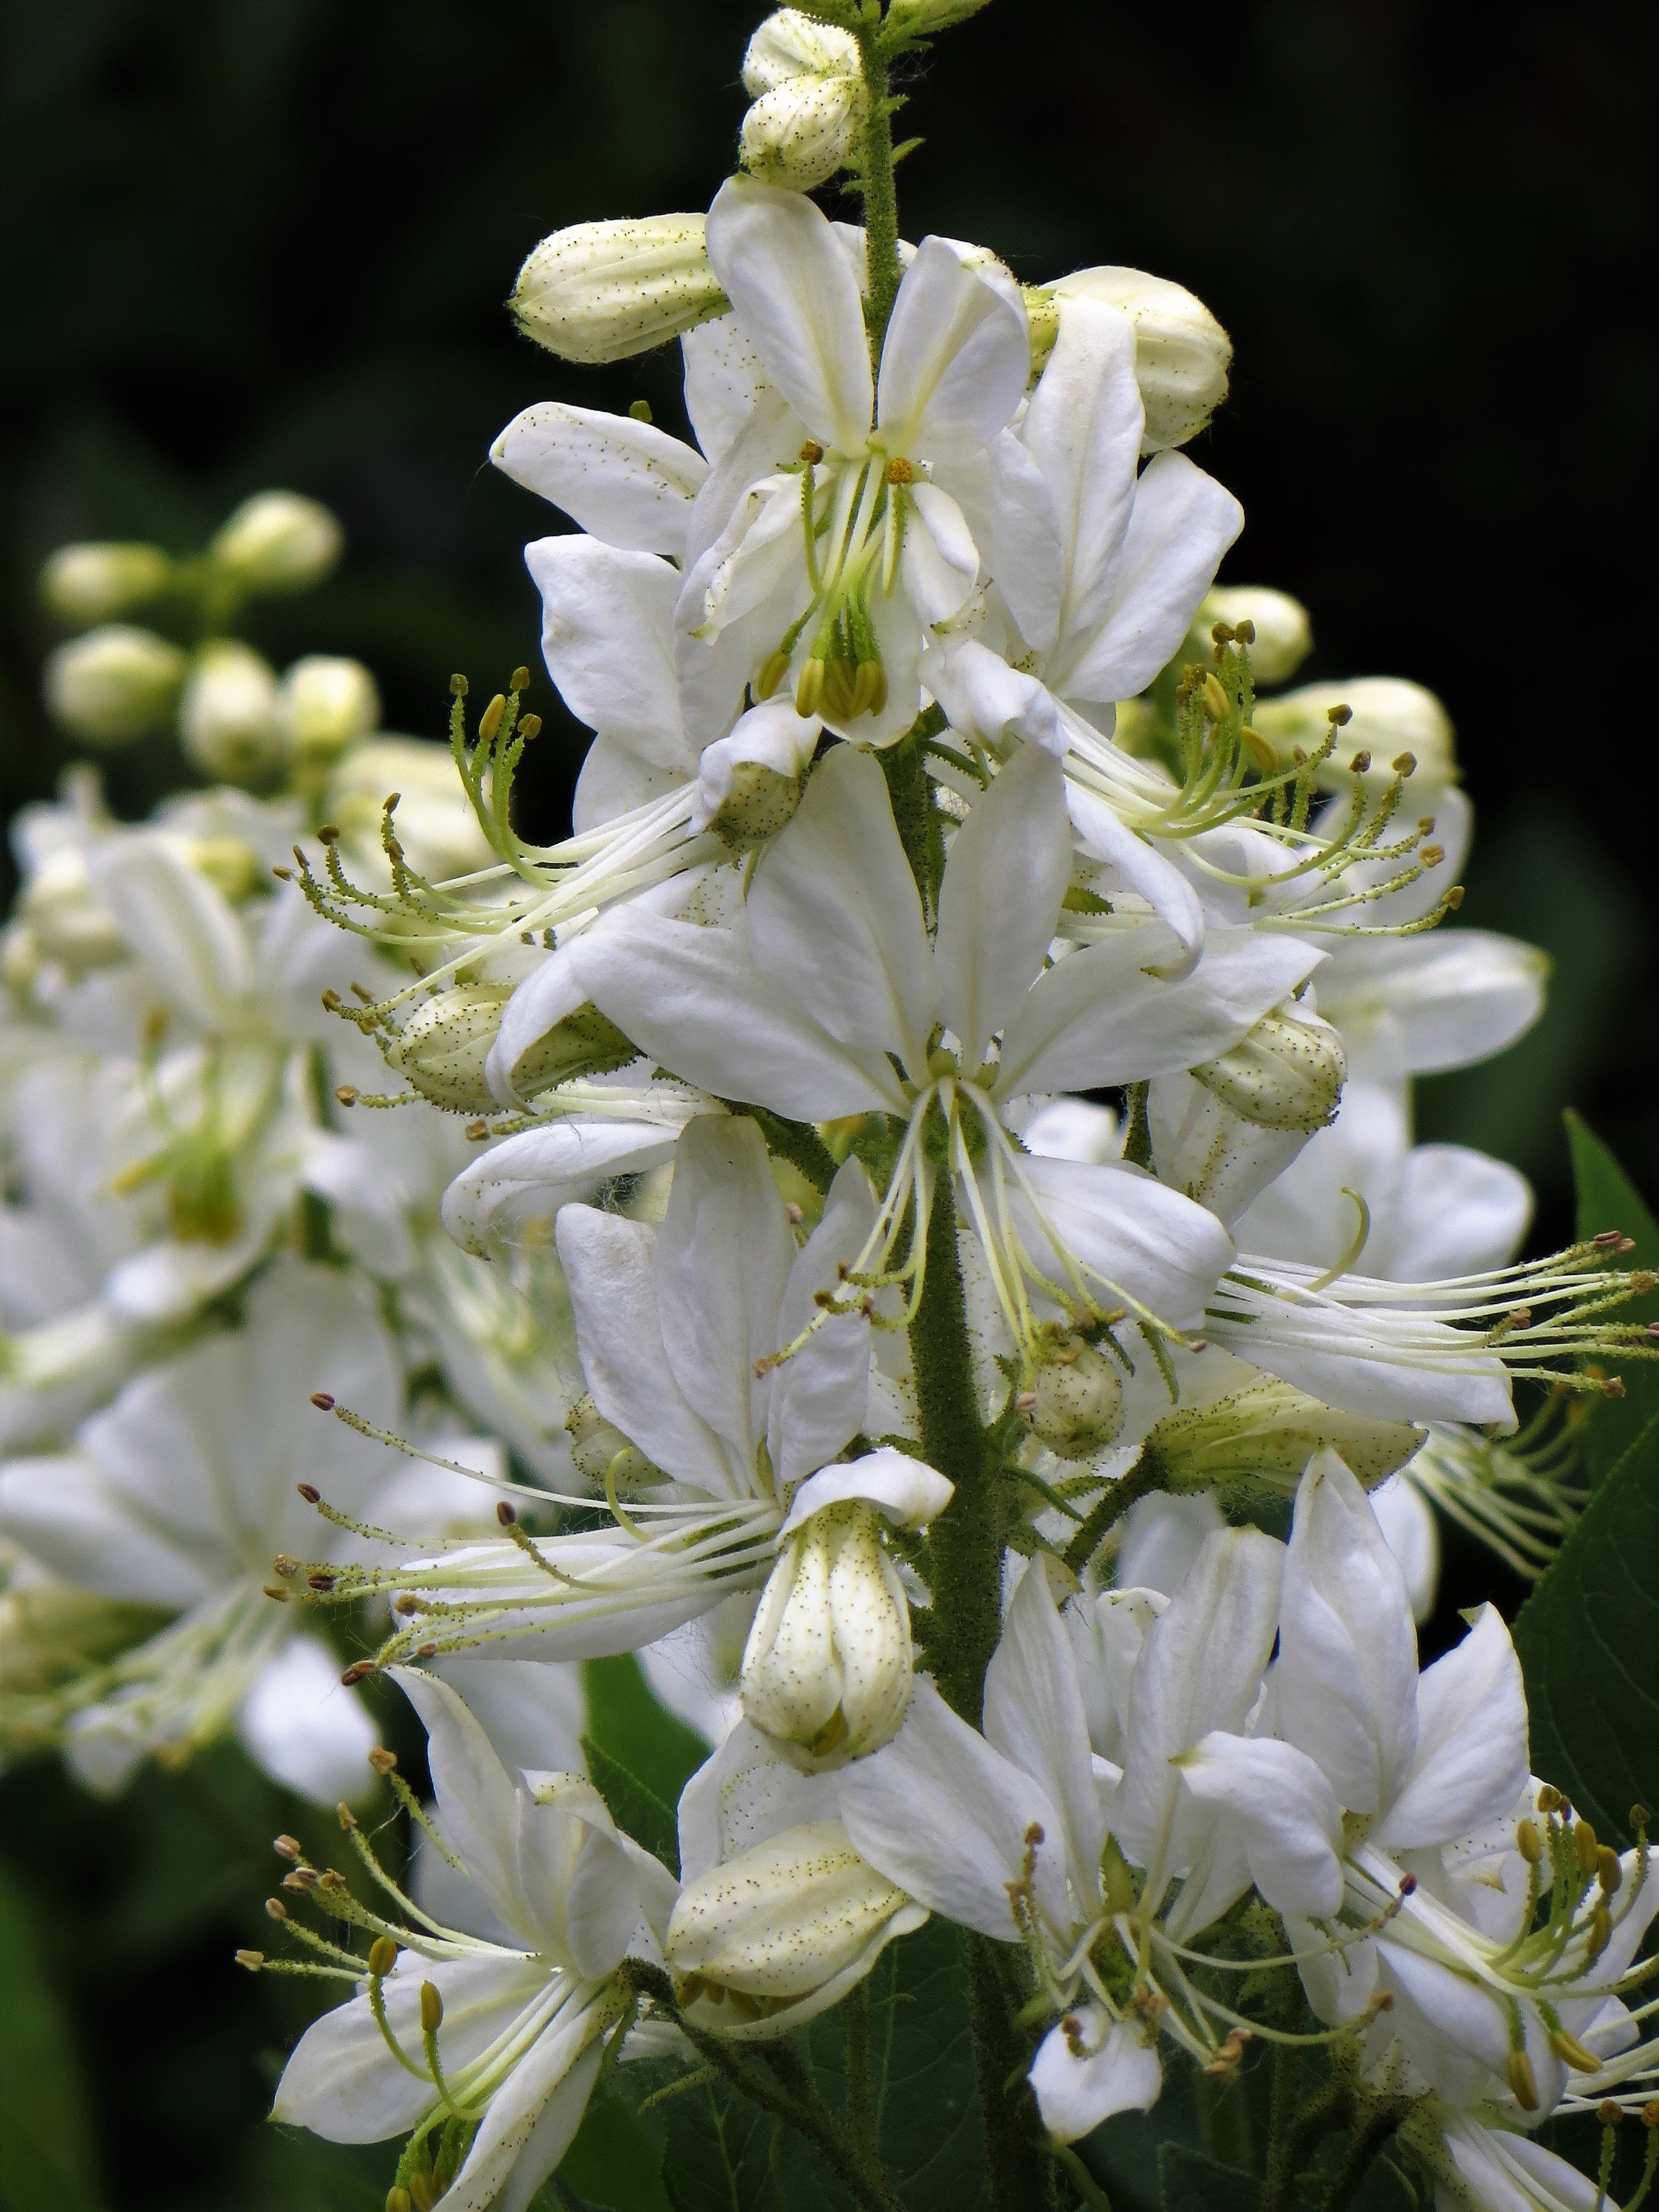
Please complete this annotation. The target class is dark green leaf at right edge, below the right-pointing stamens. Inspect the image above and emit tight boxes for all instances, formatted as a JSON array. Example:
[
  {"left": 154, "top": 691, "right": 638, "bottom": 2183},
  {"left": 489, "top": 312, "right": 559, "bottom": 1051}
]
[{"left": 1515, "top": 1413, "right": 1659, "bottom": 1843}]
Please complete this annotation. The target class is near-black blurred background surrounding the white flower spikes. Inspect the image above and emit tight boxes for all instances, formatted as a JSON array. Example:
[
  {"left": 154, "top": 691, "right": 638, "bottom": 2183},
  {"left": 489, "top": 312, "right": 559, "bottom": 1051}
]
[{"left": 0, "top": 0, "right": 1659, "bottom": 2212}]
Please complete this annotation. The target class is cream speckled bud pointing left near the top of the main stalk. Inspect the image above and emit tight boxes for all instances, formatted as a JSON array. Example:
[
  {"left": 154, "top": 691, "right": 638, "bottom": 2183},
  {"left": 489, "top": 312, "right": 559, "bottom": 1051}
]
[{"left": 509, "top": 215, "right": 728, "bottom": 361}]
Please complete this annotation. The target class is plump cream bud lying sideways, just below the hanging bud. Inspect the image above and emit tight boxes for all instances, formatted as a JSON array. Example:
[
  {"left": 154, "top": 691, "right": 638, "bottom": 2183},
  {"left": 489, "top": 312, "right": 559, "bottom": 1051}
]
[{"left": 664, "top": 1820, "right": 927, "bottom": 2017}]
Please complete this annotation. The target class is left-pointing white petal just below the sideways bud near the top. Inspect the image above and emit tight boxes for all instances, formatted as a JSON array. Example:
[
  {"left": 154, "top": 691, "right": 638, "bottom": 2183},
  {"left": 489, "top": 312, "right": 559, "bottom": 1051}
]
[{"left": 489, "top": 400, "right": 708, "bottom": 553}]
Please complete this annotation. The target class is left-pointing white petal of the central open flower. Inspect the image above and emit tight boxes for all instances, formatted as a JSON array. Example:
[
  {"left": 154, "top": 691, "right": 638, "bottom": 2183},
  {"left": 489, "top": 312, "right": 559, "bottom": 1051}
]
[{"left": 571, "top": 902, "right": 920, "bottom": 1121}]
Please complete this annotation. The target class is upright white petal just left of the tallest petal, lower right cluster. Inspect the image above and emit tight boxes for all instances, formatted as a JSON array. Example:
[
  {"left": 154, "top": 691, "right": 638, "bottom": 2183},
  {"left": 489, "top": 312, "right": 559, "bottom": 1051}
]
[{"left": 1113, "top": 1528, "right": 1285, "bottom": 1896}]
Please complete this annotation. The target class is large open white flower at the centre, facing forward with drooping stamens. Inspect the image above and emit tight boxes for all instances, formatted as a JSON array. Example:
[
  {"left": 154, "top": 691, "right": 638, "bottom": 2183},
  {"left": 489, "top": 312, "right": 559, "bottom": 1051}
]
[{"left": 571, "top": 748, "right": 1316, "bottom": 1371}]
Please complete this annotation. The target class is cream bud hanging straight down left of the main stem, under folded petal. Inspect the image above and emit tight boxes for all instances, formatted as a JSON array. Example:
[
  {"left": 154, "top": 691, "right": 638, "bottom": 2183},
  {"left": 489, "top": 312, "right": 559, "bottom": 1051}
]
[{"left": 739, "top": 1498, "right": 911, "bottom": 1767}]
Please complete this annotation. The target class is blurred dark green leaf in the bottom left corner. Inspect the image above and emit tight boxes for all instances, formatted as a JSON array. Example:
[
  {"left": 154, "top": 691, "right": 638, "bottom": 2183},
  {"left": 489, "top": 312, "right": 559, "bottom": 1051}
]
[{"left": 0, "top": 1867, "right": 97, "bottom": 2212}]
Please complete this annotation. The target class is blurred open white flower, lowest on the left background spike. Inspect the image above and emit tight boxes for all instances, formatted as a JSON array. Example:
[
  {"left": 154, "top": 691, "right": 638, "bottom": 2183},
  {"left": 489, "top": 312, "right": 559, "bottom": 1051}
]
[{"left": 0, "top": 1261, "right": 491, "bottom": 1803}]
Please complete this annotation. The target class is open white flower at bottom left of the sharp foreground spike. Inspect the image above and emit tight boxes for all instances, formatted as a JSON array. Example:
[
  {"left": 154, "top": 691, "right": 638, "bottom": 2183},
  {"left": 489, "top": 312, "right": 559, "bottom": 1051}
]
[{"left": 272, "top": 1668, "right": 675, "bottom": 2212}]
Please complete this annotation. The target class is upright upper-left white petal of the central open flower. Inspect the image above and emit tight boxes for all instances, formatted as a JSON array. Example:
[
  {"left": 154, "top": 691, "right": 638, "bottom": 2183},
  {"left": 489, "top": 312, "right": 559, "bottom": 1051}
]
[{"left": 748, "top": 745, "right": 933, "bottom": 1079}]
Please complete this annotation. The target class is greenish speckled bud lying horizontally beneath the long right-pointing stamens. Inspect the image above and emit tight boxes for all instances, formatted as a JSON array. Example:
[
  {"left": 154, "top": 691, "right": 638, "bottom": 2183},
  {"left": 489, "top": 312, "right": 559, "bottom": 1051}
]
[{"left": 1146, "top": 1374, "right": 1422, "bottom": 1498}]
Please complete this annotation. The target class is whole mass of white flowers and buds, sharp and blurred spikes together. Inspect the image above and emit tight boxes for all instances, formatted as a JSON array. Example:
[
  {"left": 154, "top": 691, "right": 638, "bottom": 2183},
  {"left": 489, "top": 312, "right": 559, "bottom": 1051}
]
[{"left": 0, "top": 0, "right": 1659, "bottom": 2212}]
